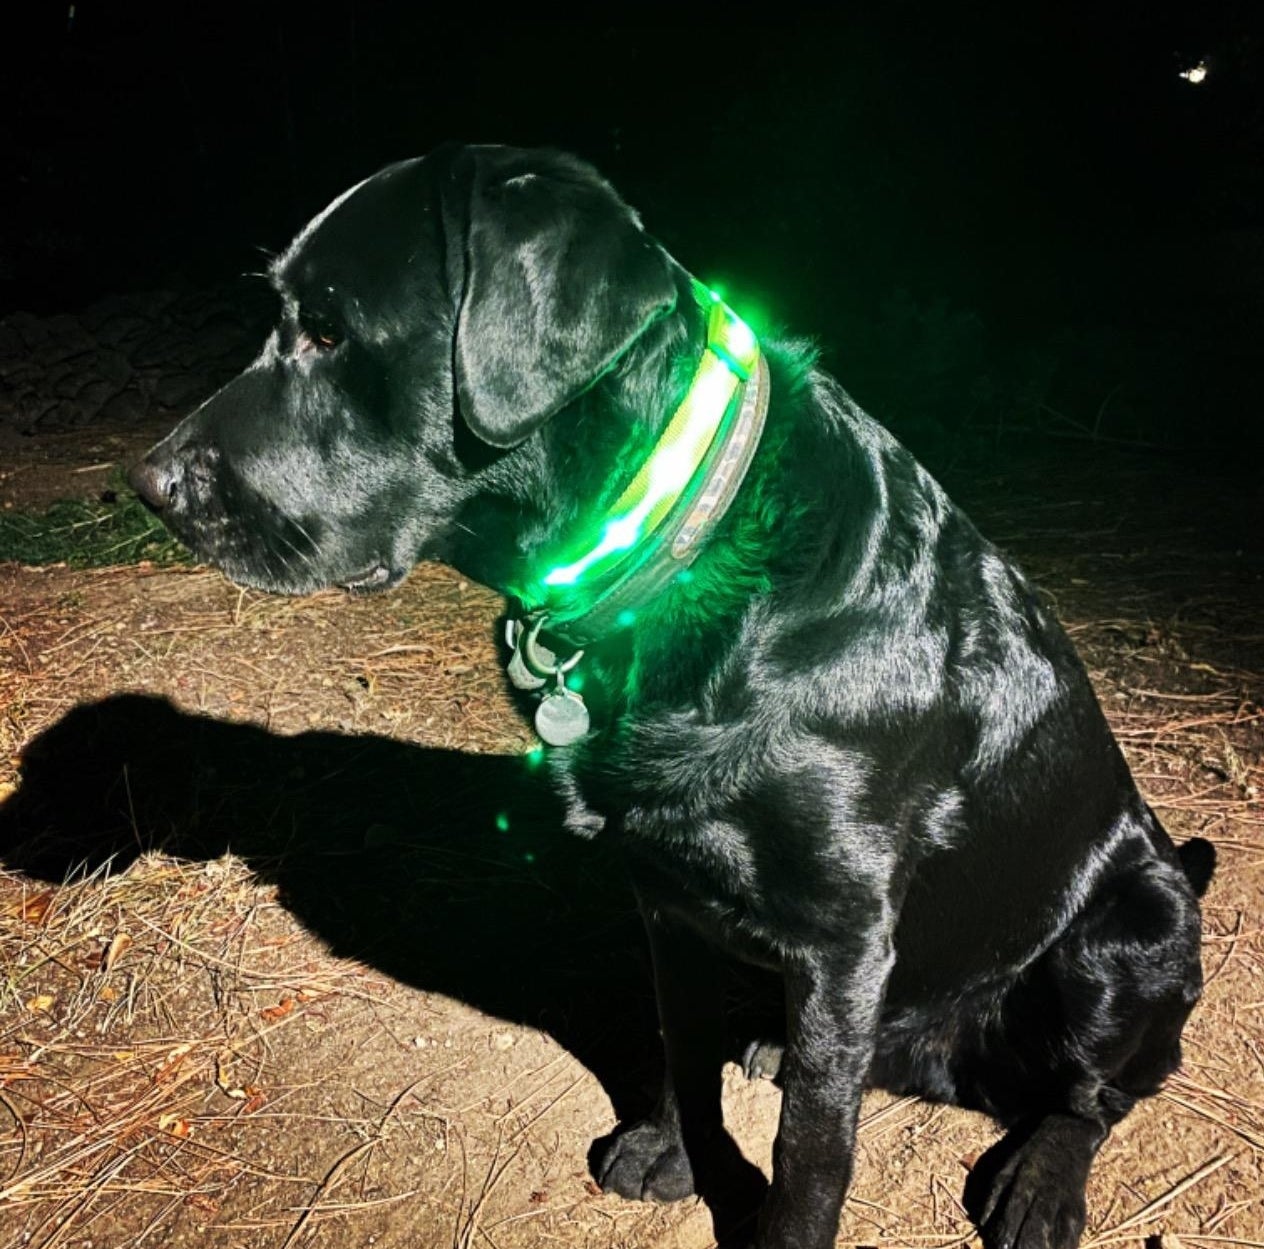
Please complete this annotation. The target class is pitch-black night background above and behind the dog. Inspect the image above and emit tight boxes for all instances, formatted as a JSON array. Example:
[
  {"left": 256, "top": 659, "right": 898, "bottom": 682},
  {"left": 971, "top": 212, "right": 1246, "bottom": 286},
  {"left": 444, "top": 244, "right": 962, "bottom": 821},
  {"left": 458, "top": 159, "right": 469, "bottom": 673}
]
[{"left": 0, "top": 0, "right": 1264, "bottom": 461}]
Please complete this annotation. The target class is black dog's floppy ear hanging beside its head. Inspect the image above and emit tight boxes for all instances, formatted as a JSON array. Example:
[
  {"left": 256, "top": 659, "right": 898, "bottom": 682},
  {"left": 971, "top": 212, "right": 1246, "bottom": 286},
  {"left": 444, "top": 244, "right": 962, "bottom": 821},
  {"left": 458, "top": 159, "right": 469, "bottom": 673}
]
[{"left": 449, "top": 148, "right": 676, "bottom": 448}]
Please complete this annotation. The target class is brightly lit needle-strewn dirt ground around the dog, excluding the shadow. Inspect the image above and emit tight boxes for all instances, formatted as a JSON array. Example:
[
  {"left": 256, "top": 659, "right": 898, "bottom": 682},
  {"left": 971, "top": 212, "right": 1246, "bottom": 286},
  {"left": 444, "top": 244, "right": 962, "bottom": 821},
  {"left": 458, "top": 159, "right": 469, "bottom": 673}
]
[{"left": 0, "top": 462, "right": 1264, "bottom": 1249}]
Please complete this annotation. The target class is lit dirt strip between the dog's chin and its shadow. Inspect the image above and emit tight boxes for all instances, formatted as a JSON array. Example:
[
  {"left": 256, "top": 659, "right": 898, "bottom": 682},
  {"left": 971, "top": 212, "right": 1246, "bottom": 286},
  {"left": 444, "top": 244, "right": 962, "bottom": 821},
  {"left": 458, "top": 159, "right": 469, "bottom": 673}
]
[{"left": 0, "top": 565, "right": 532, "bottom": 763}]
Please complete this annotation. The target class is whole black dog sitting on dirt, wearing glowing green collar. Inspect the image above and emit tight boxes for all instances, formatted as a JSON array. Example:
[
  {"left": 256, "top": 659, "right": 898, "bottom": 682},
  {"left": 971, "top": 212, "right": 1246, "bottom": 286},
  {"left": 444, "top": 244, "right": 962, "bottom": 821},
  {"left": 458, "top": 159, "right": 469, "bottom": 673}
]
[{"left": 133, "top": 147, "right": 1212, "bottom": 1249}]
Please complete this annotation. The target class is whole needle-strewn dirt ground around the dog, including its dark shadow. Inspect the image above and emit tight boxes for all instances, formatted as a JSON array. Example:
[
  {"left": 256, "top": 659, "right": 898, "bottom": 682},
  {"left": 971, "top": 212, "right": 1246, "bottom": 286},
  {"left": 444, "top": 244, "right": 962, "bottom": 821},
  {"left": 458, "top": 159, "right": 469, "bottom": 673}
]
[{"left": 0, "top": 407, "right": 1264, "bottom": 1249}]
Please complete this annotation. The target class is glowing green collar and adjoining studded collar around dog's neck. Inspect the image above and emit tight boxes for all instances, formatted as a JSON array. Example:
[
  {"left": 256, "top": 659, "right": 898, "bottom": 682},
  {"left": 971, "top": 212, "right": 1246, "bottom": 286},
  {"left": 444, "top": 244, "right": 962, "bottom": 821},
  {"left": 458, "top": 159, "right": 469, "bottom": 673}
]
[{"left": 526, "top": 279, "right": 769, "bottom": 646}]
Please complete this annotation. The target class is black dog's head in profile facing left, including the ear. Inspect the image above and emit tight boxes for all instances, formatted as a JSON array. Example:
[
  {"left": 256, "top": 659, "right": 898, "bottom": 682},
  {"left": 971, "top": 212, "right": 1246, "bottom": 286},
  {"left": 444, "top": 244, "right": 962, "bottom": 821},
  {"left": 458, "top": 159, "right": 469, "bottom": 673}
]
[{"left": 131, "top": 147, "right": 688, "bottom": 593}]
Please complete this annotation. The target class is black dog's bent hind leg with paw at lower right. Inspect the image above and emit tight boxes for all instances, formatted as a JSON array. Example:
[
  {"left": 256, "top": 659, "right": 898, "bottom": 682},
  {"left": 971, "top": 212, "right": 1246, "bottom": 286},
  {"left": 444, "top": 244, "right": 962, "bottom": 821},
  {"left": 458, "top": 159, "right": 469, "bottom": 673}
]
[{"left": 966, "top": 860, "right": 1202, "bottom": 1249}]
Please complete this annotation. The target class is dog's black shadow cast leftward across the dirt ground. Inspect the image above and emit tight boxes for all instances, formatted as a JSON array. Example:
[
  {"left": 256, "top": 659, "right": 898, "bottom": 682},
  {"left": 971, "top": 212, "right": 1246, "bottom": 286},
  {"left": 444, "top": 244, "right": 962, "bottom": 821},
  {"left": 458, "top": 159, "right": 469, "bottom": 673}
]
[{"left": 0, "top": 694, "right": 770, "bottom": 1238}]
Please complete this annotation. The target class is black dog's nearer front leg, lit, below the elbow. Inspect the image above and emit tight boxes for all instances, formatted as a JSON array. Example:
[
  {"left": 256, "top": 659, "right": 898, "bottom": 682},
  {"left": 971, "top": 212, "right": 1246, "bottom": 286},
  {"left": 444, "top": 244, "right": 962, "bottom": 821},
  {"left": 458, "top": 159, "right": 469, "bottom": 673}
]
[{"left": 756, "top": 932, "right": 891, "bottom": 1249}]
